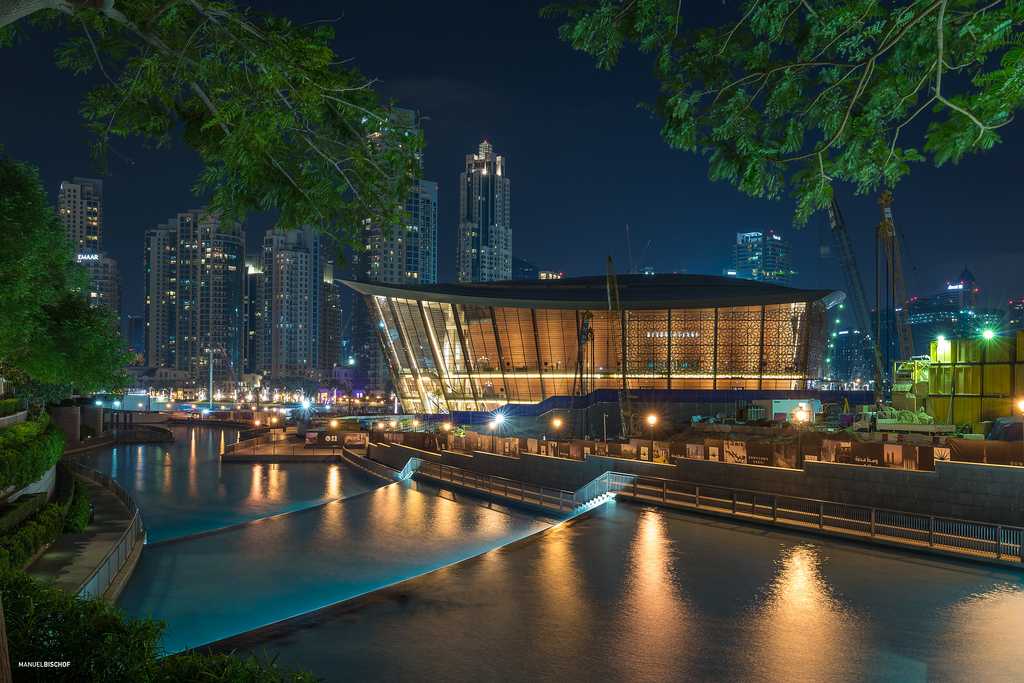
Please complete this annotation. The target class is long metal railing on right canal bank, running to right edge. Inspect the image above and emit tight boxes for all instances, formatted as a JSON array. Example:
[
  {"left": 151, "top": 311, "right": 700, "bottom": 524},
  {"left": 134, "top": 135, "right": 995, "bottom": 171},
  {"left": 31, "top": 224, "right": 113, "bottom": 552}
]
[{"left": 614, "top": 476, "right": 1024, "bottom": 563}]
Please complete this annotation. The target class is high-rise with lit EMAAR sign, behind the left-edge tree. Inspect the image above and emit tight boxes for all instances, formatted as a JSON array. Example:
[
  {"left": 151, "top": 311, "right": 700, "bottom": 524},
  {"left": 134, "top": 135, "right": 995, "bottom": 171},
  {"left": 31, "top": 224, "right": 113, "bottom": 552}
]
[{"left": 57, "top": 177, "right": 121, "bottom": 317}]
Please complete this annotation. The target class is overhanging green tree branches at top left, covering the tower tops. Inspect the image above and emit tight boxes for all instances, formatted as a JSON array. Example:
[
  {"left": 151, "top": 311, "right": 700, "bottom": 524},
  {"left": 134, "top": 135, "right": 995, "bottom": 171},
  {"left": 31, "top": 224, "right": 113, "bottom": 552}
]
[{"left": 0, "top": 0, "right": 422, "bottom": 247}]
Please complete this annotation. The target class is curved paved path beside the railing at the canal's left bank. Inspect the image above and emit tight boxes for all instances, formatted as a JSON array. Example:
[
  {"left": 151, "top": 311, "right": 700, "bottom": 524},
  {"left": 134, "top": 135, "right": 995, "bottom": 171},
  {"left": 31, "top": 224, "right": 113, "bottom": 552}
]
[{"left": 28, "top": 477, "right": 131, "bottom": 593}]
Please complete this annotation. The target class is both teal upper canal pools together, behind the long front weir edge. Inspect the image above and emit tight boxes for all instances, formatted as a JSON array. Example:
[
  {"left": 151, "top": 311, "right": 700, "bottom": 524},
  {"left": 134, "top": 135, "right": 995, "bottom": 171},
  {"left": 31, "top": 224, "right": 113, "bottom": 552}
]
[{"left": 99, "top": 428, "right": 552, "bottom": 652}]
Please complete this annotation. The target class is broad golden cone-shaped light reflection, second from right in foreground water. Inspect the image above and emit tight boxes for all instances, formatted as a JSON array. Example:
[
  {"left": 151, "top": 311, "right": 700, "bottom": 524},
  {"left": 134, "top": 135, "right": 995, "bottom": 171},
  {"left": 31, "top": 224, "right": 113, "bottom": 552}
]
[{"left": 748, "top": 545, "right": 863, "bottom": 681}]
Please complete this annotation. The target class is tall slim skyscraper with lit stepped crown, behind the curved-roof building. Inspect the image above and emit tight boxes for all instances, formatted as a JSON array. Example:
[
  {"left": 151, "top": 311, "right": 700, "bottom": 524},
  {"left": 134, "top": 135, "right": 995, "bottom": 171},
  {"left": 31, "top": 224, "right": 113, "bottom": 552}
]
[{"left": 458, "top": 140, "right": 512, "bottom": 283}]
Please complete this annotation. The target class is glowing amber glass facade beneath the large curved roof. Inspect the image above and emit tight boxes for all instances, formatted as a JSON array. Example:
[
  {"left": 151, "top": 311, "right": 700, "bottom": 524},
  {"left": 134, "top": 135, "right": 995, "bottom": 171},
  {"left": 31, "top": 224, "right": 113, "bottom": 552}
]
[{"left": 367, "top": 291, "right": 825, "bottom": 413}]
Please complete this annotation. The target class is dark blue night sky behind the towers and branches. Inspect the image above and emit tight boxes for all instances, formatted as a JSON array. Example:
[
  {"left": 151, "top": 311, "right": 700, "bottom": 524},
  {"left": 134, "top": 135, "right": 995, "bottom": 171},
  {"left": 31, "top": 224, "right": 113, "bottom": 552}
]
[{"left": 0, "top": 1, "right": 1024, "bottom": 323}]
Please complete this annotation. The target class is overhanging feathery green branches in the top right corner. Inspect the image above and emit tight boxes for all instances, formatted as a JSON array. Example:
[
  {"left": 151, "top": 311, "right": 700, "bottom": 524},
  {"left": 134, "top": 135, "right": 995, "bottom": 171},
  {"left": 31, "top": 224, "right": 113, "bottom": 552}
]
[{"left": 545, "top": 0, "right": 1024, "bottom": 224}]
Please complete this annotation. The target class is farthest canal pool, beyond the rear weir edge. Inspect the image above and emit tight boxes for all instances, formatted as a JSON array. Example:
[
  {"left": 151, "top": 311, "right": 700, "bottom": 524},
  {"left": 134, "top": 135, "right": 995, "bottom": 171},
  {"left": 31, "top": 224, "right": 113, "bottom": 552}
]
[{"left": 80, "top": 426, "right": 379, "bottom": 543}]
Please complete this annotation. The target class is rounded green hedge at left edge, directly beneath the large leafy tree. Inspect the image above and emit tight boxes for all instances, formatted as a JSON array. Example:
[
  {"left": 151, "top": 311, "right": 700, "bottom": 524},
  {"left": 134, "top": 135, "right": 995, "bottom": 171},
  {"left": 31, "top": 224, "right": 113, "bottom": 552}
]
[{"left": 0, "top": 414, "right": 65, "bottom": 489}]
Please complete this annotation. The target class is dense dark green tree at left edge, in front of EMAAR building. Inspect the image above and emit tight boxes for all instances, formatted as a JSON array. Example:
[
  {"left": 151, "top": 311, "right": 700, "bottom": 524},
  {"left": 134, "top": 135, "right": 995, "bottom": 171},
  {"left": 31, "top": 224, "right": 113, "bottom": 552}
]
[{"left": 0, "top": 156, "right": 128, "bottom": 400}]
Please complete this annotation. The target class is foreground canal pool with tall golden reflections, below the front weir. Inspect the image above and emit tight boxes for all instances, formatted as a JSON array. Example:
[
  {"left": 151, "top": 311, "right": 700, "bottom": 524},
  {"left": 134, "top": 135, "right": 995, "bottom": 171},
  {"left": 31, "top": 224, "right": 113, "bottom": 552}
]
[{"left": 229, "top": 502, "right": 1024, "bottom": 682}]
